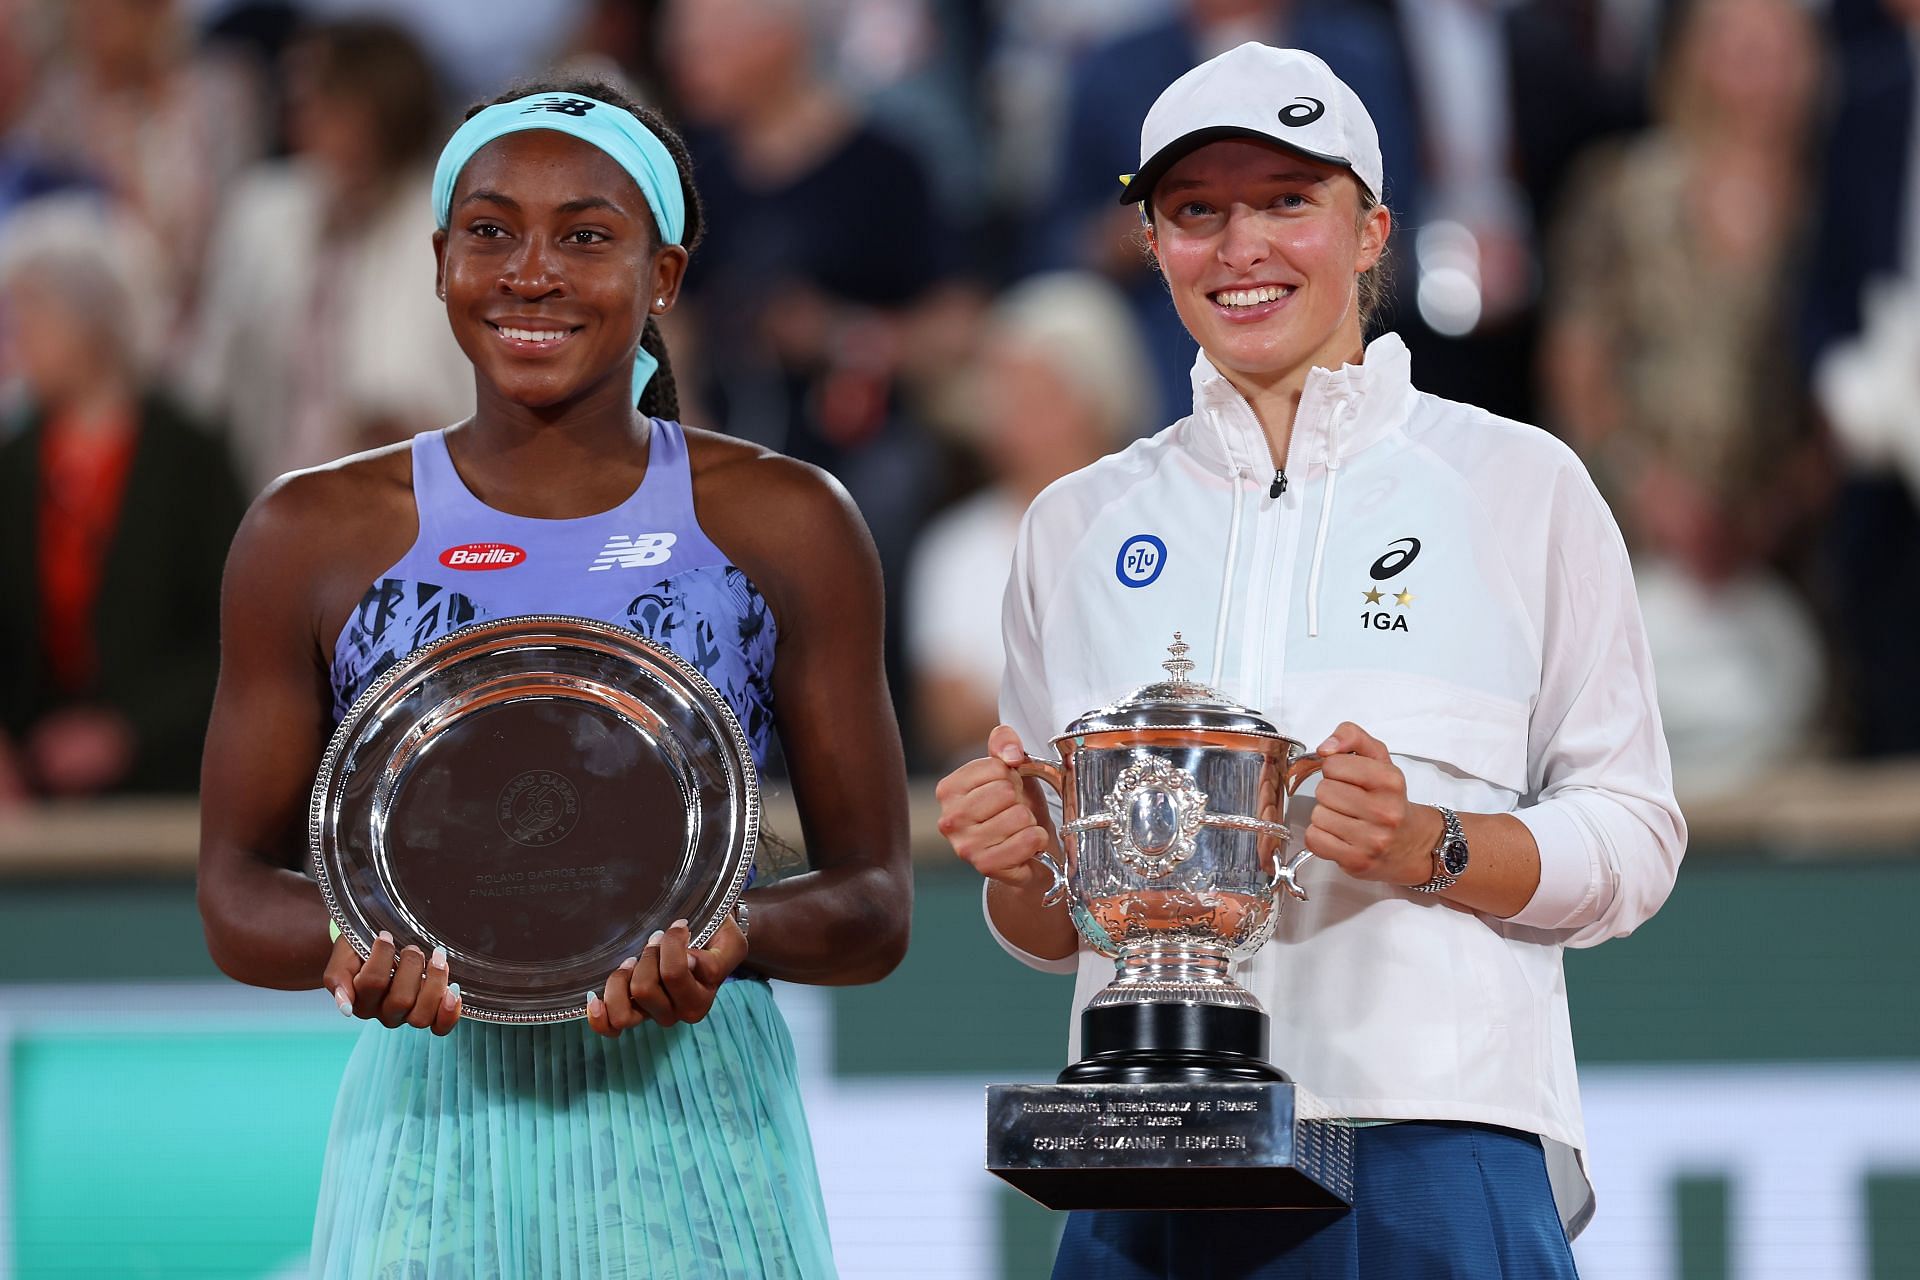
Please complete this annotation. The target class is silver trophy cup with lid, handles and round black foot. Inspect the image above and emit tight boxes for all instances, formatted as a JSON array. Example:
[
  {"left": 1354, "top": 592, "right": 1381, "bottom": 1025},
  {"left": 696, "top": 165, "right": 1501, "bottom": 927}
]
[{"left": 1020, "top": 633, "right": 1321, "bottom": 1080}]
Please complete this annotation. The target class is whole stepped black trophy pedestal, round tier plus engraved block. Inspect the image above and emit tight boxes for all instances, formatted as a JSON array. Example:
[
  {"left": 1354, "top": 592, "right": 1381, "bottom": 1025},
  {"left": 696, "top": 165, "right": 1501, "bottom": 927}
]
[{"left": 987, "top": 1002, "right": 1354, "bottom": 1209}]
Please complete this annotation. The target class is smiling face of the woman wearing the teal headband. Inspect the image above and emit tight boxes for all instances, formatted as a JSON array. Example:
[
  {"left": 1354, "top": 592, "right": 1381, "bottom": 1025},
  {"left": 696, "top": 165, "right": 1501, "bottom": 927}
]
[{"left": 434, "top": 129, "right": 687, "bottom": 409}]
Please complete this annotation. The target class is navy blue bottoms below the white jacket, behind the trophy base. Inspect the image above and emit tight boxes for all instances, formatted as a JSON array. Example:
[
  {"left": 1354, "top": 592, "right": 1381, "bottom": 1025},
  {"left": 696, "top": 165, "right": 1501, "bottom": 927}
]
[{"left": 1054, "top": 1123, "right": 1576, "bottom": 1280}]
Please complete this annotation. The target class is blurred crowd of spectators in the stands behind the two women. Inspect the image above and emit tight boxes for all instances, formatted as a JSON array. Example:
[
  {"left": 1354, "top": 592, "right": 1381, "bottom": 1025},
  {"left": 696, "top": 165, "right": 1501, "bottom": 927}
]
[{"left": 0, "top": 0, "right": 1920, "bottom": 802}]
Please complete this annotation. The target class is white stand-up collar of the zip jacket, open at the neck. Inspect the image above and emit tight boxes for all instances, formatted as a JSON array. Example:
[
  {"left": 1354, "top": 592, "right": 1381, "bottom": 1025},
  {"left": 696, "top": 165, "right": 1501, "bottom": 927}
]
[{"left": 1190, "top": 334, "right": 1413, "bottom": 476}]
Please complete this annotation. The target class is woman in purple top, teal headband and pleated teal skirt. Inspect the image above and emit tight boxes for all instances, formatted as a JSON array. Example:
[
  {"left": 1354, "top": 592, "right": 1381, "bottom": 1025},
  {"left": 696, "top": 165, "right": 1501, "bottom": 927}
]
[{"left": 200, "top": 83, "right": 910, "bottom": 1278}]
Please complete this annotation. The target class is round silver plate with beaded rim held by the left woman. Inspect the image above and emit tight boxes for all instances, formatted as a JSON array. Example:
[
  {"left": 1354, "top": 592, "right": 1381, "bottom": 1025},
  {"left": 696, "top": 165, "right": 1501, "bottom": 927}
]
[{"left": 307, "top": 616, "right": 760, "bottom": 1023}]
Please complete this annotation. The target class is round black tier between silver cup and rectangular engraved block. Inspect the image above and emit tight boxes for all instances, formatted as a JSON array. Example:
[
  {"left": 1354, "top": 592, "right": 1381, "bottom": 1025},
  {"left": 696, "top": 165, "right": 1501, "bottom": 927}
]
[{"left": 1058, "top": 1002, "right": 1288, "bottom": 1084}]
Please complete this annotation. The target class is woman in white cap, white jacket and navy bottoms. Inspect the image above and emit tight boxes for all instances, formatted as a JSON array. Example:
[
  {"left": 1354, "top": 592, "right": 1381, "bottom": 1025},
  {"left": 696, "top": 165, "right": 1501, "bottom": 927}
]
[{"left": 939, "top": 44, "right": 1686, "bottom": 1280}]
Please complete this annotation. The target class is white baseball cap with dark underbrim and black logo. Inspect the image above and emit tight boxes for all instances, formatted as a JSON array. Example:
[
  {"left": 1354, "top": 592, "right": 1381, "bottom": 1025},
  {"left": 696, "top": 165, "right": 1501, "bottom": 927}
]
[{"left": 1119, "top": 40, "right": 1384, "bottom": 203}]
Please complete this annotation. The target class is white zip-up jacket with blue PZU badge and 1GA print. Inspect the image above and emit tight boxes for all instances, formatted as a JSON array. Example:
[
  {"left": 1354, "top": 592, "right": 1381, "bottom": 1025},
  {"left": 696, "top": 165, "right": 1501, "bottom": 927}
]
[{"left": 996, "top": 334, "right": 1686, "bottom": 1234}]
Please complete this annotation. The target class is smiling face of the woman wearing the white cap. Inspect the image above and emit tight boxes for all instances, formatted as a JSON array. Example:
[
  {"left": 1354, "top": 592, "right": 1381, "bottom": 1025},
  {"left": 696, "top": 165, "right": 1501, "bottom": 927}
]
[{"left": 1152, "top": 138, "right": 1392, "bottom": 401}]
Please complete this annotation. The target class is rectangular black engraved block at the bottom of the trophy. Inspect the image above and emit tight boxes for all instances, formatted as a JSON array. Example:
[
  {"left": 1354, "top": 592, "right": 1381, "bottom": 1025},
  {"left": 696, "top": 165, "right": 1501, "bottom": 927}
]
[{"left": 987, "top": 1082, "right": 1354, "bottom": 1211}]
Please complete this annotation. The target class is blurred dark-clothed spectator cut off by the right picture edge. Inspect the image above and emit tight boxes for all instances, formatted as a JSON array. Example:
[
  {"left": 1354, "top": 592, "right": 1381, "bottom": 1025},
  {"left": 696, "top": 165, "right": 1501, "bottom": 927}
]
[{"left": 1807, "top": 0, "right": 1920, "bottom": 756}]
